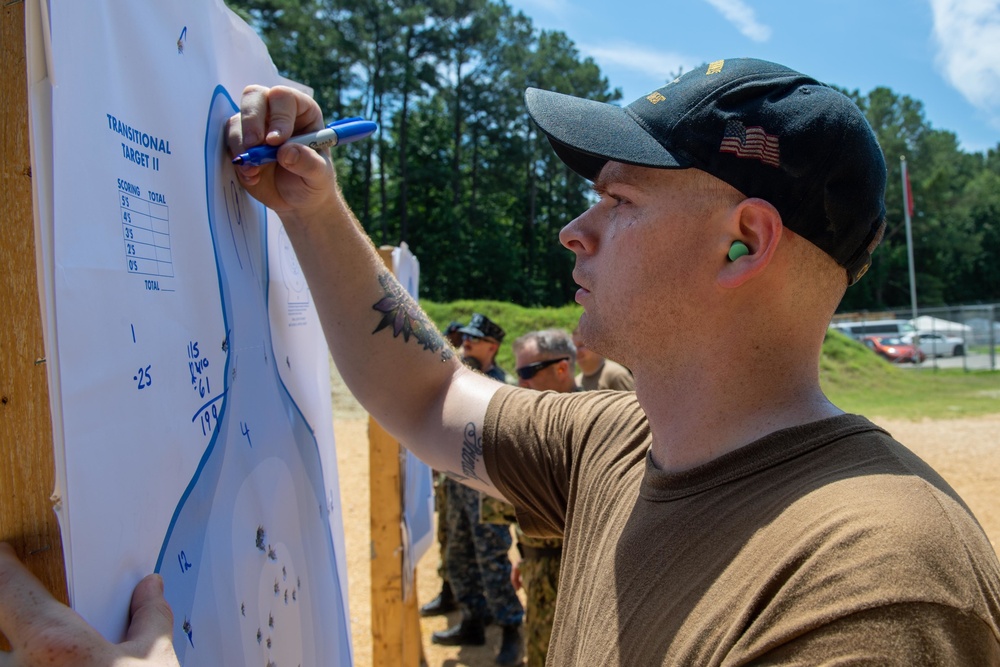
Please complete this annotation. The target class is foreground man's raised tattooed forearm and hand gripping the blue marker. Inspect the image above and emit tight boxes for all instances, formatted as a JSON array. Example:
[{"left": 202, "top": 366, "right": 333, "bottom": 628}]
[{"left": 227, "top": 86, "right": 501, "bottom": 494}]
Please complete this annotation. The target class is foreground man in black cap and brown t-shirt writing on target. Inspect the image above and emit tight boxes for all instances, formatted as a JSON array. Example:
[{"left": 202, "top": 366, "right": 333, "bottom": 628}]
[{"left": 0, "top": 59, "right": 1000, "bottom": 665}]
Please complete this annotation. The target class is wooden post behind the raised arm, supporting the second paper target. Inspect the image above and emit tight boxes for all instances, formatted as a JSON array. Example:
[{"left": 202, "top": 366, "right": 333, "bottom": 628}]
[{"left": 368, "top": 246, "right": 424, "bottom": 667}]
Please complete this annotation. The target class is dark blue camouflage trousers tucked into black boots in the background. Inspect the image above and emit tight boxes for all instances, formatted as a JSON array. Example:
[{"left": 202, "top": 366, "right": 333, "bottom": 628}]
[{"left": 445, "top": 479, "right": 524, "bottom": 625}]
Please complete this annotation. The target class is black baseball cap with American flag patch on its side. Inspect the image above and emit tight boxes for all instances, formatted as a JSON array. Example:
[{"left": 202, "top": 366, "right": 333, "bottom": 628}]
[{"left": 525, "top": 58, "right": 886, "bottom": 285}]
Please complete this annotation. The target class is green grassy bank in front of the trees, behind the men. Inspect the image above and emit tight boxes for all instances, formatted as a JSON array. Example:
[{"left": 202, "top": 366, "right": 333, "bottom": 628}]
[{"left": 421, "top": 301, "right": 1000, "bottom": 420}]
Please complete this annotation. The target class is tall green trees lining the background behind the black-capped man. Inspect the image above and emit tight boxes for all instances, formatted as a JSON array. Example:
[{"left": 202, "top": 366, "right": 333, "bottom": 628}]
[{"left": 227, "top": 0, "right": 1000, "bottom": 310}]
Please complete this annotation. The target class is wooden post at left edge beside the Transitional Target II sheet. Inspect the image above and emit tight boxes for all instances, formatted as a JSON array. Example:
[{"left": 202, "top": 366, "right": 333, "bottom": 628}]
[{"left": 0, "top": 2, "right": 67, "bottom": 648}]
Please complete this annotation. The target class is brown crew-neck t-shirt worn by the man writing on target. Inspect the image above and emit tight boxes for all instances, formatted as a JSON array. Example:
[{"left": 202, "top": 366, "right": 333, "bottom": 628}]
[{"left": 483, "top": 387, "right": 1000, "bottom": 667}]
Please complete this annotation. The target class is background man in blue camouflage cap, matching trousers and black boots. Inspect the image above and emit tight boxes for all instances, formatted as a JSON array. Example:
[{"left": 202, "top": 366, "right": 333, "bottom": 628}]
[{"left": 434, "top": 313, "right": 524, "bottom": 665}]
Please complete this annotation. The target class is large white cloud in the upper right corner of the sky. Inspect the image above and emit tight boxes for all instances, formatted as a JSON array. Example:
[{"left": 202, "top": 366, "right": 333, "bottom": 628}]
[{"left": 931, "top": 0, "right": 1000, "bottom": 118}]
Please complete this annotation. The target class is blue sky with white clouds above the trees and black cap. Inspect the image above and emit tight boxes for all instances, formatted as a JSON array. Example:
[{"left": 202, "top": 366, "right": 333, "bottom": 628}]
[{"left": 508, "top": 0, "right": 1000, "bottom": 152}]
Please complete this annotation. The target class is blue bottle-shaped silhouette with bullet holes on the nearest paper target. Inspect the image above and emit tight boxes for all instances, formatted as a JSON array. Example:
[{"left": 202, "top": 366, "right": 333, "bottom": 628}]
[{"left": 156, "top": 85, "right": 352, "bottom": 667}]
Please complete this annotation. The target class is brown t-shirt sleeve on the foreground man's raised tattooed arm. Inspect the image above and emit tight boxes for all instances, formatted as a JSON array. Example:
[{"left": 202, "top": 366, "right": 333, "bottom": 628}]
[{"left": 483, "top": 387, "right": 648, "bottom": 537}]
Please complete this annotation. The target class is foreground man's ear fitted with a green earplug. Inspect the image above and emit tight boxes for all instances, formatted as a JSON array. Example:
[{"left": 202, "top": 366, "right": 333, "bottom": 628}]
[{"left": 718, "top": 198, "right": 784, "bottom": 288}]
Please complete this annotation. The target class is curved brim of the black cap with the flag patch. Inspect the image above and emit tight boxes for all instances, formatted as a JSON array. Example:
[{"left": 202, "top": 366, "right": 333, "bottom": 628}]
[{"left": 524, "top": 88, "right": 688, "bottom": 181}]
